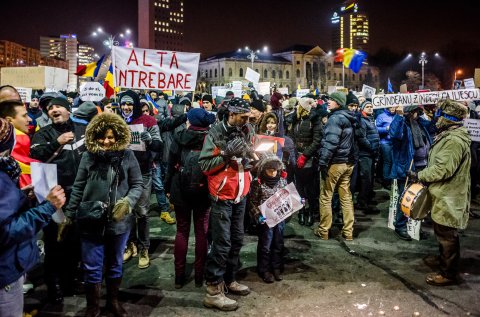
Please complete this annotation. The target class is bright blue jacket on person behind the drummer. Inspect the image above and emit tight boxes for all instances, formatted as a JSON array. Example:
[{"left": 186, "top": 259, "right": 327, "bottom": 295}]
[{"left": 388, "top": 115, "right": 432, "bottom": 179}]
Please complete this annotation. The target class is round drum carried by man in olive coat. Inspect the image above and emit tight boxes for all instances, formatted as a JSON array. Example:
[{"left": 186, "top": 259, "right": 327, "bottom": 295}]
[{"left": 400, "top": 183, "right": 432, "bottom": 220}]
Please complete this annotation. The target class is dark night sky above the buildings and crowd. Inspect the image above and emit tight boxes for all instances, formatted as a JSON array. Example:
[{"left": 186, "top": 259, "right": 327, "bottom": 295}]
[{"left": 0, "top": 0, "right": 480, "bottom": 62}]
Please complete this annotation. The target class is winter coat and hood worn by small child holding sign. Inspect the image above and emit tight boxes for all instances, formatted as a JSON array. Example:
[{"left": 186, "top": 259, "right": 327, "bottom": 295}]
[{"left": 249, "top": 155, "right": 287, "bottom": 220}]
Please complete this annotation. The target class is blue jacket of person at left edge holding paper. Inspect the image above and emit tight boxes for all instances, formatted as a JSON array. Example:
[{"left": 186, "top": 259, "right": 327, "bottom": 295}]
[{"left": 0, "top": 171, "right": 55, "bottom": 288}]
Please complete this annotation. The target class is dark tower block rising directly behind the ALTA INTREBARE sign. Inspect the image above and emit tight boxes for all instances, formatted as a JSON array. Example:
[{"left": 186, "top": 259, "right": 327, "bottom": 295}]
[{"left": 138, "top": 0, "right": 185, "bottom": 51}]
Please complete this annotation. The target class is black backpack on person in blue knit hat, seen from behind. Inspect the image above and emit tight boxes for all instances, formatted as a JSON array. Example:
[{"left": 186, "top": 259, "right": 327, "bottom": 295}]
[{"left": 180, "top": 143, "right": 208, "bottom": 197}]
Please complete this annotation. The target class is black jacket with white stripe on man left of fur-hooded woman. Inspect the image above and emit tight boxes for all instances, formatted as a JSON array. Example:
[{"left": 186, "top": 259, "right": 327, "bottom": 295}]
[{"left": 30, "top": 120, "right": 86, "bottom": 193}]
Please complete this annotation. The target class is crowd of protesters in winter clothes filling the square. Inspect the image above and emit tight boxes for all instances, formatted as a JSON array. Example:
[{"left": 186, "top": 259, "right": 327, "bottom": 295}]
[{"left": 0, "top": 86, "right": 480, "bottom": 316}]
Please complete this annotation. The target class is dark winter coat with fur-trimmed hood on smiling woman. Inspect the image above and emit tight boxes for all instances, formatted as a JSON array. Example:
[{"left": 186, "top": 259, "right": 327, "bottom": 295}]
[{"left": 66, "top": 113, "right": 144, "bottom": 235}]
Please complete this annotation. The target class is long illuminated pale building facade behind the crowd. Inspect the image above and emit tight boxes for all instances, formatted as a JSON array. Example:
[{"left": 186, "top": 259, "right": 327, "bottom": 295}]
[{"left": 197, "top": 45, "right": 379, "bottom": 93}]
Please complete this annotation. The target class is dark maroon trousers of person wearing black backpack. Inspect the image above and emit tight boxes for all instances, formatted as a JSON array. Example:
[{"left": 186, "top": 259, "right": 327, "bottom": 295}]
[{"left": 173, "top": 205, "right": 210, "bottom": 281}]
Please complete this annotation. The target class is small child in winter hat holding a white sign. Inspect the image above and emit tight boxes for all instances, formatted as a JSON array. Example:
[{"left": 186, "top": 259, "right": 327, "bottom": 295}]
[{"left": 250, "top": 154, "right": 287, "bottom": 283}]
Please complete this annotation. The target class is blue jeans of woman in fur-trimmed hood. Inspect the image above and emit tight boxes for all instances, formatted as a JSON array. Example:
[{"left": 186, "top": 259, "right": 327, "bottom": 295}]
[{"left": 81, "top": 232, "right": 128, "bottom": 284}]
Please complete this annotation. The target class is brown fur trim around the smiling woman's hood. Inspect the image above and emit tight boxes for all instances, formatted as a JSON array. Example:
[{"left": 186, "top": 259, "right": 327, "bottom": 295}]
[{"left": 85, "top": 112, "right": 131, "bottom": 153}]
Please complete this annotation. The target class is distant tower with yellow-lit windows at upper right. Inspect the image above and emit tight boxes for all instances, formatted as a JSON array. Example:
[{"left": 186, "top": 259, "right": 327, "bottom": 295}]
[{"left": 331, "top": 1, "right": 370, "bottom": 52}]
